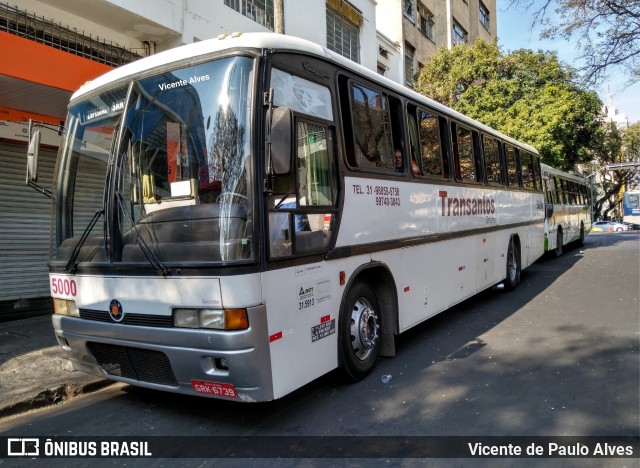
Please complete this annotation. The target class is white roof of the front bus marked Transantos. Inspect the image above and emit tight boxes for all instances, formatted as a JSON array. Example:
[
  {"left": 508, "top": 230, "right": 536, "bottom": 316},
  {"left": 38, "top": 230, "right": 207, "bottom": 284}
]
[{"left": 71, "top": 33, "right": 538, "bottom": 154}]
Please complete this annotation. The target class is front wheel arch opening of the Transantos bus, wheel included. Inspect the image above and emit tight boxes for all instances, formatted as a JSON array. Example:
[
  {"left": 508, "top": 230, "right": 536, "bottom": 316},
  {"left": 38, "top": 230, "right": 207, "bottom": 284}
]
[{"left": 338, "top": 264, "right": 398, "bottom": 382}]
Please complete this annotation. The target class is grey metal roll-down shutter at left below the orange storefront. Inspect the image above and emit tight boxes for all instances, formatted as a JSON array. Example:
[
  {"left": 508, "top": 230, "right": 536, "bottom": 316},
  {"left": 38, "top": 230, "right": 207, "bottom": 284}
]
[{"left": 0, "top": 143, "right": 56, "bottom": 302}]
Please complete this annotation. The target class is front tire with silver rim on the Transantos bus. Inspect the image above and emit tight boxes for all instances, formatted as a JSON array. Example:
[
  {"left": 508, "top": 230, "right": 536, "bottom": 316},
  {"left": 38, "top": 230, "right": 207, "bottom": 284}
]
[{"left": 339, "top": 281, "right": 382, "bottom": 382}]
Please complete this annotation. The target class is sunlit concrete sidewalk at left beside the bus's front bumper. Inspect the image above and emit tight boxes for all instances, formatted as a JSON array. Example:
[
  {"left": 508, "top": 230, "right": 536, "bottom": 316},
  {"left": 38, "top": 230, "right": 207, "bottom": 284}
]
[{"left": 0, "top": 315, "right": 113, "bottom": 418}]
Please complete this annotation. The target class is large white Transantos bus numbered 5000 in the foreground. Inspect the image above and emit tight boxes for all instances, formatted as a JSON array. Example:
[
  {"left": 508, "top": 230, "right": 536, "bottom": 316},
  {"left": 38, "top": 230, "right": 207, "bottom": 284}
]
[{"left": 32, "top": 34, "right": 544, "bottom": 402}]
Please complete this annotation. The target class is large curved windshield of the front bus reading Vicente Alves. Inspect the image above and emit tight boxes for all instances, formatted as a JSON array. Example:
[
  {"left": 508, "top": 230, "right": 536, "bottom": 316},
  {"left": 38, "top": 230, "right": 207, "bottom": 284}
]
[{"left": 52, "top": 57, "right": 255, "bottom": 268}]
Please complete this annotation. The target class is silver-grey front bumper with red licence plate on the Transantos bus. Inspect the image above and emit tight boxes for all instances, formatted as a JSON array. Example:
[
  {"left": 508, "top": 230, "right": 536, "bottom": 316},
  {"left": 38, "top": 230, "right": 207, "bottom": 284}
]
[{"left": 52, "top": 306, "right": 273, "bottom": 402}]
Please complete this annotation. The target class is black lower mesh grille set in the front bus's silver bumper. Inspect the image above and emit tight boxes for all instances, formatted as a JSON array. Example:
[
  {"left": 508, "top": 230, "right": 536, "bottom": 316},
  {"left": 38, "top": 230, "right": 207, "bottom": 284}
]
[{"left": 87, "top": 342, "right": 178, "bottom": 387}]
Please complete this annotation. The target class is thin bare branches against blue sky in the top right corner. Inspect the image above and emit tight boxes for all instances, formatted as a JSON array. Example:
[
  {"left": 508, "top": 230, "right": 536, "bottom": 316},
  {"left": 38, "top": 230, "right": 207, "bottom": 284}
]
[{"left": 511, "top": 0, "right": 640, "bottom": 84}]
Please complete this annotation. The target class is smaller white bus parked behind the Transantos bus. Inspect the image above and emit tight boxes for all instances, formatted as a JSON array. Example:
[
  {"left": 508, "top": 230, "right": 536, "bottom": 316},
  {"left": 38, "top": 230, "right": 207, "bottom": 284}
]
[{"left": 541, "top": 164, "right": 592, "bottom": 257}]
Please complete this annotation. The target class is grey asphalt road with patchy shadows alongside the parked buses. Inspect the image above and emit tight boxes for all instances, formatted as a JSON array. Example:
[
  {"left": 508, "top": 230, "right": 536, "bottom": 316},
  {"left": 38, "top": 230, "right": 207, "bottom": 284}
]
[{"left": 0, "top": 231, "right": 640, "bottom": 466}]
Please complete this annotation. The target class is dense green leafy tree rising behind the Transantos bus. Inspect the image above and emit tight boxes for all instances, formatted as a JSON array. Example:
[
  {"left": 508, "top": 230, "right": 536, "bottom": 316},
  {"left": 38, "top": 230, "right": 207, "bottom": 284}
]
[{"left": 415, "top": 40, "right": 604, "bottom": 170}]
